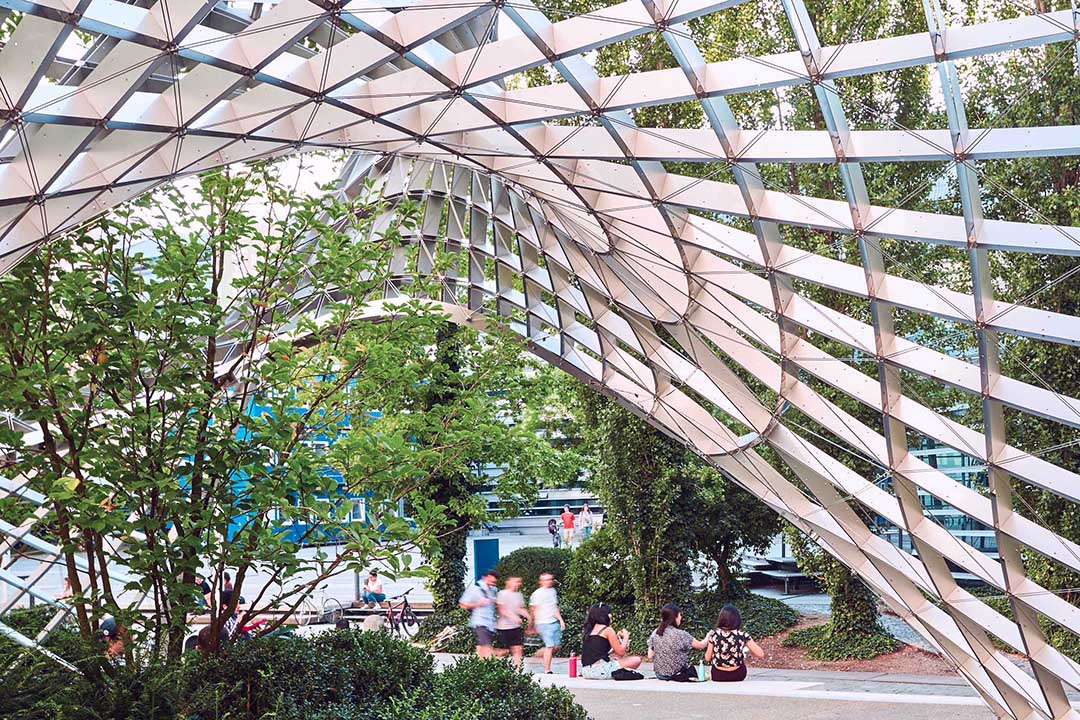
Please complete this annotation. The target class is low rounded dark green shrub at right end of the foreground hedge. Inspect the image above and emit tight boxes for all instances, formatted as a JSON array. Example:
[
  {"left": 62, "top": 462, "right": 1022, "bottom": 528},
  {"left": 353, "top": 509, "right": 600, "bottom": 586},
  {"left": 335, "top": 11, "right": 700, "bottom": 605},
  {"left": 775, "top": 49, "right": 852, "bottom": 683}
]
[{"left": 384, "top": 657, "right": 588, "bottom": 720}]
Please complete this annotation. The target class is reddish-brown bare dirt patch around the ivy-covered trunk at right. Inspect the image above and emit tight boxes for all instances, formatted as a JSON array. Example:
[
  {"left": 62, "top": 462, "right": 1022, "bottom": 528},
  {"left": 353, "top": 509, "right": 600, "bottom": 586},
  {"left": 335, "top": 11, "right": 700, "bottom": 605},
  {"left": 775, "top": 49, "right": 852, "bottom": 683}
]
[{"left": 747, "top": 615, "right": 956, "bottom": 675}]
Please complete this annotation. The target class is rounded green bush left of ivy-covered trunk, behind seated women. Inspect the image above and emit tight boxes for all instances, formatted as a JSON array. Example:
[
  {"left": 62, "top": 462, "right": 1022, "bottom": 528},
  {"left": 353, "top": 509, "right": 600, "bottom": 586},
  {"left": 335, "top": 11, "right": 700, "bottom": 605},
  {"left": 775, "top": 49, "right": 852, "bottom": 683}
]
[{"left": 558, "top": 526, "right": 634, "bottom": 611}]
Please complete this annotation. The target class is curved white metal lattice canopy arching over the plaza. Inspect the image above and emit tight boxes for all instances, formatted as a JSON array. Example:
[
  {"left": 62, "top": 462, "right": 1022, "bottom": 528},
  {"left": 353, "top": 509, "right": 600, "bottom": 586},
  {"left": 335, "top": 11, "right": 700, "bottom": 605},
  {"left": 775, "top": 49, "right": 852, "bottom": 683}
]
[{"left": 0, "top": 0, "right": 1080, "bottom": 718}]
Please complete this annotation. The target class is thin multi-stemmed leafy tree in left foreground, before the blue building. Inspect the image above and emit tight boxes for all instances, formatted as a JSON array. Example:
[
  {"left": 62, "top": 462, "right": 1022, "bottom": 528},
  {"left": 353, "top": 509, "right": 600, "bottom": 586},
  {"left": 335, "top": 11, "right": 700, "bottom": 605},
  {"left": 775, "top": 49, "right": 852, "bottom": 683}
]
[{"left": 0, "top": 164, "right": 540, "bottom": 671}]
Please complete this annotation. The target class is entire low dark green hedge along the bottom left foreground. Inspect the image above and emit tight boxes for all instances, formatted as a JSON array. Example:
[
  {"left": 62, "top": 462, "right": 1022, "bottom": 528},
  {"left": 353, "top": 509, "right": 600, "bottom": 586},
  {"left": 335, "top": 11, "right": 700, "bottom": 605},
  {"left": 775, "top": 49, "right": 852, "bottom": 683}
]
[{"left": 0, "top": 615, "right": 585, "bottom": 720}]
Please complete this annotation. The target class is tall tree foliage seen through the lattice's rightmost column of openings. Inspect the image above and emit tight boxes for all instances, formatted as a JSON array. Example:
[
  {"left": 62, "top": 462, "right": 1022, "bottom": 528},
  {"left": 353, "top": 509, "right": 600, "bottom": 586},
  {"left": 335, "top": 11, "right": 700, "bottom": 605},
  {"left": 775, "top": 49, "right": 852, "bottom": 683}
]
[{"left": 961, "top": 0, "right": 1080, "bottom": 658}]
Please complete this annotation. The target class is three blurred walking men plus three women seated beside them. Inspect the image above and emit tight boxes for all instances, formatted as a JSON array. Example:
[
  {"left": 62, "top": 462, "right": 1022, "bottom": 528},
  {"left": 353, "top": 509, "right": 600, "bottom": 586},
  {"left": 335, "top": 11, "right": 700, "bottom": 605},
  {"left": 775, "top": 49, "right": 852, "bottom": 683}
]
[{"left": 459, "top": 570, "right": 765, "bottom": 682}]
